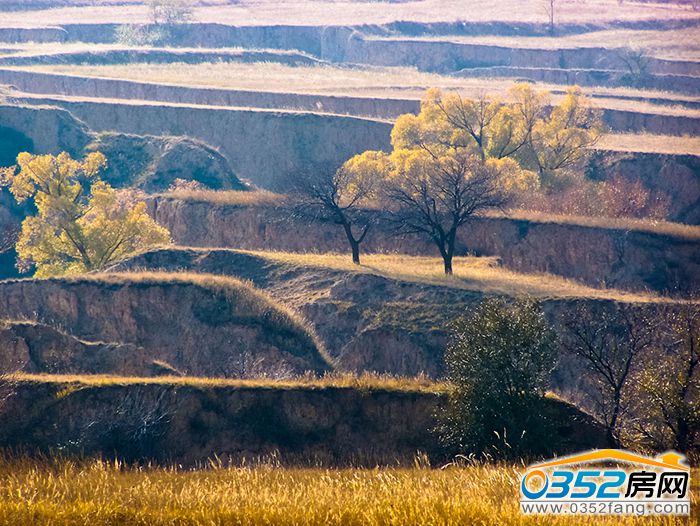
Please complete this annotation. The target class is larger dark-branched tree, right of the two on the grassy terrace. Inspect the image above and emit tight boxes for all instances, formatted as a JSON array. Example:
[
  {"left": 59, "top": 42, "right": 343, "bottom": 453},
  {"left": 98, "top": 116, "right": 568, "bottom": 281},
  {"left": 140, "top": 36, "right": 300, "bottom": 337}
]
[{"left": 384, "top": 154, "right": 507, "bottom": 274}]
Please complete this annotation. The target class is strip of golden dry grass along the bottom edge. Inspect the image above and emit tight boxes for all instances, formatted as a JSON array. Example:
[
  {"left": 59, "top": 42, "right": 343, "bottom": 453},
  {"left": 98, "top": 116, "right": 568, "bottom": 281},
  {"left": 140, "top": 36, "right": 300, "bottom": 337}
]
[{"left": 0, "top": 457, "right": 700, "bottom": 526}]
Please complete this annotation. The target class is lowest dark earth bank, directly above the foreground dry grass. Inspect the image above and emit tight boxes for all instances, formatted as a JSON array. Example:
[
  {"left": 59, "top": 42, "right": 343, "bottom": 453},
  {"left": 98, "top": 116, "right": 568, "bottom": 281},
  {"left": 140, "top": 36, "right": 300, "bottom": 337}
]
[{"left": 0, "top": 377, "right": 602, "bottom": 466}]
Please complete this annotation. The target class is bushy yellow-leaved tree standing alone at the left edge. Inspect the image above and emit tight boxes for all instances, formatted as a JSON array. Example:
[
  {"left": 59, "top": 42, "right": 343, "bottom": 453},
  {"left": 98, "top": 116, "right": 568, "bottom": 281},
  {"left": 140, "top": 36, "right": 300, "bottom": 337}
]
[{"left": 0, "top": 152, "right": 170, "bottom": 277}]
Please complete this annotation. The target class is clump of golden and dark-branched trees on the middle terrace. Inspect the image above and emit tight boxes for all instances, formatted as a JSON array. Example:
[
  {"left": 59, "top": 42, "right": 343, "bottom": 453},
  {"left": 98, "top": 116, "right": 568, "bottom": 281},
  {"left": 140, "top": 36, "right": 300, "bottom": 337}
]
[{"left": 293, "top": 84, "right": 603, "bottom": 274}]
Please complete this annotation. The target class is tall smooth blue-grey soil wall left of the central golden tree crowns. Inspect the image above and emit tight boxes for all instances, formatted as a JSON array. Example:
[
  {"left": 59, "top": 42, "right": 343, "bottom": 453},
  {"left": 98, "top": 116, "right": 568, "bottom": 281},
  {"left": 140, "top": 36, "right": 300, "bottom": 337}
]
[{"left": 13, "top": 99, "right": 391, "bottom": 188}]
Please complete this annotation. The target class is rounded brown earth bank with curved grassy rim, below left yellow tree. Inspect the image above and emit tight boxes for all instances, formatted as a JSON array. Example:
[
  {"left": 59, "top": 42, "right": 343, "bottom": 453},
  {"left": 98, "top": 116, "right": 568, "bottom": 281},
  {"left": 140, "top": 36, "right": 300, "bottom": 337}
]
[{"left": 0, "top": 273, "right": 329, "bottom": 377}]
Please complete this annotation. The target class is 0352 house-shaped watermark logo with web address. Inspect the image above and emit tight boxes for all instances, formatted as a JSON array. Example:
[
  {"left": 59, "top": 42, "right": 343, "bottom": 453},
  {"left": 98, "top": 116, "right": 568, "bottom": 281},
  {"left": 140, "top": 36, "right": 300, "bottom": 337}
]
[{"left": 520, "top": 449, "right": 690, "bottom": 516}]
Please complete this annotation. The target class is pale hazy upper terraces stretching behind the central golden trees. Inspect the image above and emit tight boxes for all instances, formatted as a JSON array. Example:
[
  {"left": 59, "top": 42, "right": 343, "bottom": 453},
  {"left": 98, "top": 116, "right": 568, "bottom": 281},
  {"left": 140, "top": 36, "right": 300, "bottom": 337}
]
[{"left": 0, "top": 0, "right": 700, "bottom": 188}]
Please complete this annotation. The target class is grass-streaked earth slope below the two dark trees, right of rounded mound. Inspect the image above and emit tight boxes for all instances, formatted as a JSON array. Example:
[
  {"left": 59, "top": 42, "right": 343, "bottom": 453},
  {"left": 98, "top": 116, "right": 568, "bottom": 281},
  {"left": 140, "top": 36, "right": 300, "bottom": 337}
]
[{"left": 112, "top": 248, "right": 688, "bottom": 380}]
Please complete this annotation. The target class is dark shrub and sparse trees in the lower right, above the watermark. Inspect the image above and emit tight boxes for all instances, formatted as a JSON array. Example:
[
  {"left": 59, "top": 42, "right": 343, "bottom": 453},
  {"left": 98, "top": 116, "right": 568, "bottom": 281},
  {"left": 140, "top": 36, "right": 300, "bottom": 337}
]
[{"left": 440, "top": 299, "right": 700, "bottom": 458}]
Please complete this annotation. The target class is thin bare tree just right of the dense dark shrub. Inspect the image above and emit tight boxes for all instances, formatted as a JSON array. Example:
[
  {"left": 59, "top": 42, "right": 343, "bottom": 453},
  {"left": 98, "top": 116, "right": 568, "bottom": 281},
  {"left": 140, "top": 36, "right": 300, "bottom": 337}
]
[{"left": 563, "top": 304, "right": 657, "bottom": 447}]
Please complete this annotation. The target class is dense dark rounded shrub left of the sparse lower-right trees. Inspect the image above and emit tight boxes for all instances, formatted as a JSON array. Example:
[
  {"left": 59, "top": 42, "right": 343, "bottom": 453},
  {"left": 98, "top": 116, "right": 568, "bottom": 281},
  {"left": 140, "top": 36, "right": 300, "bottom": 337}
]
[{"left": 439, "top": 299, "right": 557, "bottom": 458}]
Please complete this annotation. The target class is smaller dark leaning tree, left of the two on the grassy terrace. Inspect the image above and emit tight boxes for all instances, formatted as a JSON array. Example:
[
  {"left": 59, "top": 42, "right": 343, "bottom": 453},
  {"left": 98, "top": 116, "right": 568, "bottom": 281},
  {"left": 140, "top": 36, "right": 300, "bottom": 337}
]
[{"left": 292, "top": 168, "right": 378, "bottom": 265}]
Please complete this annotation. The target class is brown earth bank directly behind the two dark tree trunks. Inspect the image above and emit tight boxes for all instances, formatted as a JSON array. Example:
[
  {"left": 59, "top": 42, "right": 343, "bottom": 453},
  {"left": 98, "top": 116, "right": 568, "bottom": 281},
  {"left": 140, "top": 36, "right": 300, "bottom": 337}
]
[{"left": 149, "top": 197, "right": 700, "bottom": 293}]
